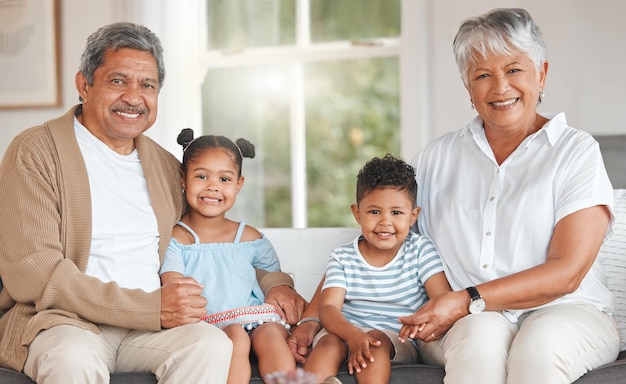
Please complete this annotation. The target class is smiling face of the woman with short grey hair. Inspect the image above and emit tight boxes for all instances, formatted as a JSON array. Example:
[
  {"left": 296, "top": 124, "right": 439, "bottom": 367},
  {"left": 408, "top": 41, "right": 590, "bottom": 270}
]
[{"left": 467, "top": 51, "right": 548, "bottom": 134}]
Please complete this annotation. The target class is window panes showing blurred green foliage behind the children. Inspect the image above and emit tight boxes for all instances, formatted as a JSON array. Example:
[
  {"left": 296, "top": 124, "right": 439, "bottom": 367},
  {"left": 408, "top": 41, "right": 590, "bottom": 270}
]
[{"left": 202, "top": 0, "right": 400, "bottom": 227}]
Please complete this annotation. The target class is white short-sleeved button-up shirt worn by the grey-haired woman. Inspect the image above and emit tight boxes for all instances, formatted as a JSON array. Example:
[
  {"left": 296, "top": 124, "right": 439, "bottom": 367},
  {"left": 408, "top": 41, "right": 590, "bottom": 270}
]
[{"left": 412, "top": 113, "right": 613, "bottom": 322}]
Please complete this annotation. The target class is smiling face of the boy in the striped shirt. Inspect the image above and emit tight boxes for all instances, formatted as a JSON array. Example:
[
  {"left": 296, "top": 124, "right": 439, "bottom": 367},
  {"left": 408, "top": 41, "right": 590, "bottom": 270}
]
[{"left": 352, "top": 187, "right": 419, "bottom": 257}]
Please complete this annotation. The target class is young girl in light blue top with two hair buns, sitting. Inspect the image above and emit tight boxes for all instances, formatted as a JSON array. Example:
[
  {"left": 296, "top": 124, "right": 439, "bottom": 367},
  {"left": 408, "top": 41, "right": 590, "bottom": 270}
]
[{"left": 161, "top": 128, "right": 296, "bottom": 383}]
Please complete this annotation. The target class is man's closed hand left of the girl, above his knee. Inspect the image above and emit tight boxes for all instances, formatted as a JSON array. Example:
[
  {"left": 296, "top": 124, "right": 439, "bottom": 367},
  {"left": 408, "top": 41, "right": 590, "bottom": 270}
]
[{"left": 161, "top": 277, "right": 207, "bottom": 328}]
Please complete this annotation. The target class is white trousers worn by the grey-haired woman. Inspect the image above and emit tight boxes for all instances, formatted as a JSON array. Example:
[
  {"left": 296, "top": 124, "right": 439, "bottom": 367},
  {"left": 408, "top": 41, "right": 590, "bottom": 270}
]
[{"left": 419, "top": 303, "right": 620, "bottom": 384}]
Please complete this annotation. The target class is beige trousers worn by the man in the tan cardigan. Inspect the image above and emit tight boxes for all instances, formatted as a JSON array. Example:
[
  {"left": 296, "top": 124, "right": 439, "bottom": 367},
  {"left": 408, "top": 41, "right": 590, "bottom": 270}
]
[{"left": 24, "top": 322, "right": 232, "bottom": 384}]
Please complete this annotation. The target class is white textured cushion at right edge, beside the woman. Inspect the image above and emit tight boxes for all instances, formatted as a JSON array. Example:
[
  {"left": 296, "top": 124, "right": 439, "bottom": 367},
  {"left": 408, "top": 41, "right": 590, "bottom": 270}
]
[{"left": 599, "top": 189, "right": 626, "bottom": 351}]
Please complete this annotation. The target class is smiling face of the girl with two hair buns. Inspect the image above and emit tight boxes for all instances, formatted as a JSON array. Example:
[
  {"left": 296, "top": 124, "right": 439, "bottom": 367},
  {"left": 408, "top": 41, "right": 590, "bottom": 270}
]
[{"left": 182, "top": 148, "right": 243, "bottom": 217}]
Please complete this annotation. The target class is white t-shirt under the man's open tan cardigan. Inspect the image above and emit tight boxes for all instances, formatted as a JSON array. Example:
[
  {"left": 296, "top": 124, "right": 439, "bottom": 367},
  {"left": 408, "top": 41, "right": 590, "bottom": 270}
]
[{"left": 74, "top": 118, "right": 160, "bottom": 292}]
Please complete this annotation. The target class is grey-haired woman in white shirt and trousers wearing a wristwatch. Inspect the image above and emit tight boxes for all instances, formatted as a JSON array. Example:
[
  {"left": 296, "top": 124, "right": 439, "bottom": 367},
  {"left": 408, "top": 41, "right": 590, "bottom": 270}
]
[{"left": 401, "top": 9, "right": 619, "bottom": 384}]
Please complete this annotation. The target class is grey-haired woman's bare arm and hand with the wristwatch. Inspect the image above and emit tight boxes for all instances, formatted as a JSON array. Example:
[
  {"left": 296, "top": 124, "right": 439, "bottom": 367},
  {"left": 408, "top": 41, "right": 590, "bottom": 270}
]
[{"left": 401, "top": 205, "right": 611, "bottom": 341}]
